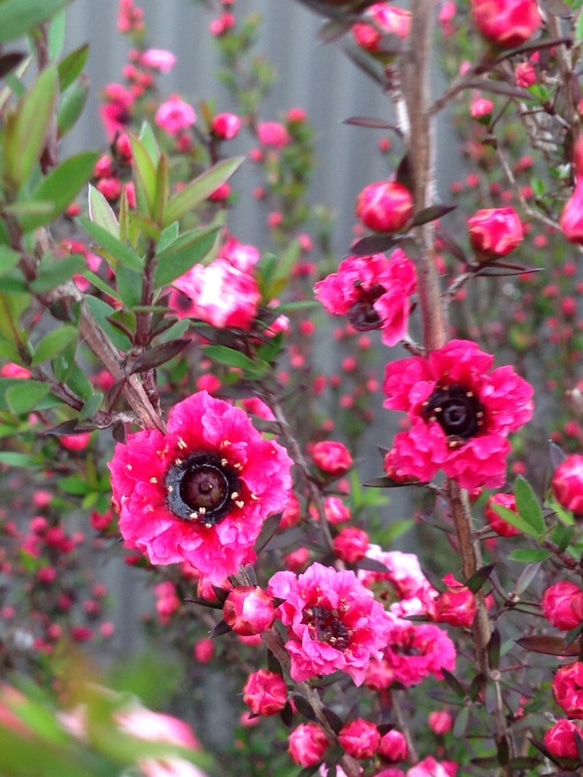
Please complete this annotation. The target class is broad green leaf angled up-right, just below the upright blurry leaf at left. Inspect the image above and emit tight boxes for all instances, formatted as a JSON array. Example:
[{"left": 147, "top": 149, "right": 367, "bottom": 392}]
[{"left": 19, "top": 151, "right": 99, "bottom": 232}]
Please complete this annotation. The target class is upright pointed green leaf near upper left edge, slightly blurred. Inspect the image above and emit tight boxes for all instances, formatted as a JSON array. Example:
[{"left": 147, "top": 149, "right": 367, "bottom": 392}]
[{"left": 0, "top": 65, "right": 59, "bottom": 188}]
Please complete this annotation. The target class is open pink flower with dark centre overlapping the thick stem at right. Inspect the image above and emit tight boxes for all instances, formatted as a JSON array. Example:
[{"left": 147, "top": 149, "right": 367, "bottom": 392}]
[{"left": 383, "top": 340, "right": 533, "bottom": 490}]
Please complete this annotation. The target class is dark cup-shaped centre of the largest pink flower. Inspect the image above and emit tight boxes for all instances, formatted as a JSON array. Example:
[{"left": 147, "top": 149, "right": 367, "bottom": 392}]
[{"left": 165, "top": 452, "right": 240, "bottom": 527}]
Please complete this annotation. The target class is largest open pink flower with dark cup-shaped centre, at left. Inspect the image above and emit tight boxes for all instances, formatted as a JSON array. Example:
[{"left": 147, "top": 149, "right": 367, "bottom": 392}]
[{"left": 109, "top": 391, "right": 292, "bottom": 584}]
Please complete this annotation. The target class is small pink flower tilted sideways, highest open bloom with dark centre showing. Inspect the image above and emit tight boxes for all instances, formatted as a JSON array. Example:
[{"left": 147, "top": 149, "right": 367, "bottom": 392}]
[{"left": 314, "top": 248, "right": 416, "bottom": 345}]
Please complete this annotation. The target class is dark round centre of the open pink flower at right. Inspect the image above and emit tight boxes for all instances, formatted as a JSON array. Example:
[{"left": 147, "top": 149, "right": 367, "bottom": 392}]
[{"left": 421, "top": 384, "right": 484, "bottom": 448}]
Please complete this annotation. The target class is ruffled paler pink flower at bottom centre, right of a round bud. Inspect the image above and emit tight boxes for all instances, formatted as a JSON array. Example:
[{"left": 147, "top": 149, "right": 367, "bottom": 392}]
[{"left": 268, "top": 563, "right": 391, "bottom": 685}]
